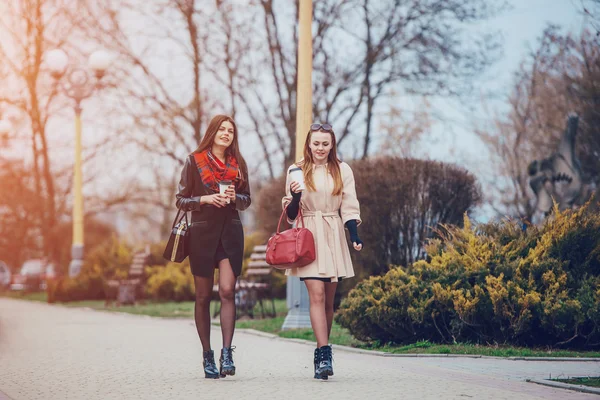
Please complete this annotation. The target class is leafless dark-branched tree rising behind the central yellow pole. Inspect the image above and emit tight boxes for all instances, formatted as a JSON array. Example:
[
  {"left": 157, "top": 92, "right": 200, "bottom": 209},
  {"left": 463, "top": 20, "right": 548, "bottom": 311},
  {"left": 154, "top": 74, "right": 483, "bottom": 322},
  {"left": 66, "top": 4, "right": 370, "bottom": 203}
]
[{"left": 246, "top": 0, "right": 503, "bottom": 164}]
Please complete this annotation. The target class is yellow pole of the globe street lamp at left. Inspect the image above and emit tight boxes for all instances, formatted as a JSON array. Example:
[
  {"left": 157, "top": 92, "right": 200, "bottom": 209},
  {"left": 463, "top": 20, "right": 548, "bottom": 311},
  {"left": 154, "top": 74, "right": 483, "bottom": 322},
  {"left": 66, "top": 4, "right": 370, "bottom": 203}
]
[{"left": 69, "top": 101, "right": 83, "bottom": 277}]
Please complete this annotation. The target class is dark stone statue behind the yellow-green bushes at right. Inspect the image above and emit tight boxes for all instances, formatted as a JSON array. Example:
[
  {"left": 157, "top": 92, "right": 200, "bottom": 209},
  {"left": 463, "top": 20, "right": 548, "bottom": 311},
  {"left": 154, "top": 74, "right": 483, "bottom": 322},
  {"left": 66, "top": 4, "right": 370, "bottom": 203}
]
[{"left": 528, "top": 115, "right": 590, "bottom": 222}]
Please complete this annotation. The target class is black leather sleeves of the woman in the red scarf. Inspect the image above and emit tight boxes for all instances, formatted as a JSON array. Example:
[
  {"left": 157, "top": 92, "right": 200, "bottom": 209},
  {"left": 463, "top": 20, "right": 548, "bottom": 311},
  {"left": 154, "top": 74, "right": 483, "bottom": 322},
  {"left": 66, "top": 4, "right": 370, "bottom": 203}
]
[{"left": 175, "top": 156, "right": 251, "bottom": 214}]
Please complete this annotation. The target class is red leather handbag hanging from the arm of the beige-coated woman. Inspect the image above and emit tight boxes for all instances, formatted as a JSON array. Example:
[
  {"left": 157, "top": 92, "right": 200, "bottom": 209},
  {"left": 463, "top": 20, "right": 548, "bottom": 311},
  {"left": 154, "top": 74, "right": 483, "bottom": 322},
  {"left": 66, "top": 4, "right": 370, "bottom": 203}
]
[{"left": 266, "top": 206, "right": 316, "bottom": 269}]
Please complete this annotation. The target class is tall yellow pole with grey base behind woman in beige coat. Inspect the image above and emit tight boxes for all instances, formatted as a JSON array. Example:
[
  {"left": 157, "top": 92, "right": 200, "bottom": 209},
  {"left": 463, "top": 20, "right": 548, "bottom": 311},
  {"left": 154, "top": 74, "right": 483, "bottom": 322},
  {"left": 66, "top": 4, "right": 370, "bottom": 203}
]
[{"left": 281, "top": 0, "right": 313, "bottom": 330}]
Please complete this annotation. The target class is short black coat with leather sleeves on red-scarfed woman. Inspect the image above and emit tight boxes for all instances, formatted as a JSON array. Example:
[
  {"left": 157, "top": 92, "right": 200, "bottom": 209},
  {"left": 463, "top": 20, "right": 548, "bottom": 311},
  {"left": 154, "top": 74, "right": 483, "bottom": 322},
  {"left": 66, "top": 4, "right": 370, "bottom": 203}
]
[{"left": 176, "top": 155, "right": 250, "bottom": 277}]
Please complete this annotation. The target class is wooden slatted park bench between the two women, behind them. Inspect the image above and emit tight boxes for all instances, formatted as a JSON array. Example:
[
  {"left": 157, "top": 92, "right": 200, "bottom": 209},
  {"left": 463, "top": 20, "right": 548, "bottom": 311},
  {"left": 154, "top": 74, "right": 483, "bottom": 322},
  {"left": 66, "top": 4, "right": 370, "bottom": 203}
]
[{"left": 213, "top": 245, "right": 275, "bottom": 318}]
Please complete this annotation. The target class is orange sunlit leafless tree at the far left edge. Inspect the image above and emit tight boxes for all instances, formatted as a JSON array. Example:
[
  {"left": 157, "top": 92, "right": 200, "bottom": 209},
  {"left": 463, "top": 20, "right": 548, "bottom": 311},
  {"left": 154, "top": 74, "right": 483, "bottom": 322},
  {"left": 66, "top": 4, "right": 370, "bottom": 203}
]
[{"left": 0, "top": 0, "right": 81, "bottom": 262}]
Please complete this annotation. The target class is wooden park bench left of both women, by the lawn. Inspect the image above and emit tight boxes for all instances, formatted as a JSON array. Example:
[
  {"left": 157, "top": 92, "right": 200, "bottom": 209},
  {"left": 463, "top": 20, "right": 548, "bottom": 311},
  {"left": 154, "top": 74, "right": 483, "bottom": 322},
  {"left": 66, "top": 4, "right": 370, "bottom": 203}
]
[{"left": 104, "top": 246, "right": 150, "bottom": 306}]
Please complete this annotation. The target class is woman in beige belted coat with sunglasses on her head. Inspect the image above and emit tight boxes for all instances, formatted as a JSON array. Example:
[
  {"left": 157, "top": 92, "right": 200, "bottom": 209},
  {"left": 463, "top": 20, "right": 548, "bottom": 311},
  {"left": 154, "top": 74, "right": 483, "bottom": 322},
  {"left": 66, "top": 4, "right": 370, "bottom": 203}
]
[{"left": 283, "top": 124, "right": 362, "bottom": 379}]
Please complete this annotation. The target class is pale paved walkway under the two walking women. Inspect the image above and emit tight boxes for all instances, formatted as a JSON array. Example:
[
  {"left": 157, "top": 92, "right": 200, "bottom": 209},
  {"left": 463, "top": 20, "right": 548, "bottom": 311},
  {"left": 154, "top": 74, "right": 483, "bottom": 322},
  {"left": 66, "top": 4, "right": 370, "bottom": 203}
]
[{"left": 0, "top": 298, "right": 600, "bottom": 400}]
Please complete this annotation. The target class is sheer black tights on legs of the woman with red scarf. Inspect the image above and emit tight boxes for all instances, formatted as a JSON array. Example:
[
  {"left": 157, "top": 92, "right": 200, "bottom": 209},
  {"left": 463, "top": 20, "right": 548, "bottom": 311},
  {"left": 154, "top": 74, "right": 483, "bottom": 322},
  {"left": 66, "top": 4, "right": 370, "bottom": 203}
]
[{"left": 194, "top": 259, "right": 237, "bottom": 351}]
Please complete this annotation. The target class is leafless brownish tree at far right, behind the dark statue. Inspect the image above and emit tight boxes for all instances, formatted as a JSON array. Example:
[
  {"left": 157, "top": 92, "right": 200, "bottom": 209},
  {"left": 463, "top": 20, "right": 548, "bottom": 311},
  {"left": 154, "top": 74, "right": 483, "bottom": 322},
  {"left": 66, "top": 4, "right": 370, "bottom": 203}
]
[{"left": 476, "top": 26, "right": 600, "bottom": 219}]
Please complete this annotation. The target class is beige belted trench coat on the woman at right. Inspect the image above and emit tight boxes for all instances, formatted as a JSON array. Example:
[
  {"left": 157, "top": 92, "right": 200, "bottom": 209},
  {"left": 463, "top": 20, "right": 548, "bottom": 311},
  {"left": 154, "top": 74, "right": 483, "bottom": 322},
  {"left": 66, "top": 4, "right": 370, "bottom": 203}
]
[{"left": 282, "top": 162, "right": 362, "bottom": 282}]
